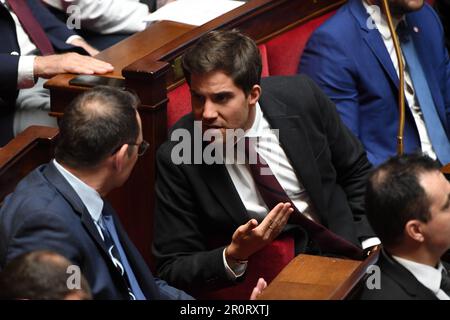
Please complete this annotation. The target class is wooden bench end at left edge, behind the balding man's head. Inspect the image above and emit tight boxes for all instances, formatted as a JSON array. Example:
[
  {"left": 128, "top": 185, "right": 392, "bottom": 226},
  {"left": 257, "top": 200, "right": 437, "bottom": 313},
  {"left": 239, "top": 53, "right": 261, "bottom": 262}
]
[{"left": 0, "top": 126, "right": 58, "bottom": 202}]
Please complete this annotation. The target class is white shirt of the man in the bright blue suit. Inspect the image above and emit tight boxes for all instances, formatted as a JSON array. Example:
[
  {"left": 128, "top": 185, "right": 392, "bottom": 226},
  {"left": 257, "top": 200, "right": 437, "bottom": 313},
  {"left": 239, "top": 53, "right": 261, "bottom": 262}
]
[{"left": 363, "top": 1, "right": 436, "bottom": 159}]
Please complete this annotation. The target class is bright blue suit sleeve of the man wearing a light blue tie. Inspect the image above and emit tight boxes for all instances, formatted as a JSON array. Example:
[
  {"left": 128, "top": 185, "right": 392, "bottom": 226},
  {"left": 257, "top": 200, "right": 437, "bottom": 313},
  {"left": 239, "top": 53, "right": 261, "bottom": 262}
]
[{"left": 298, "top": 30, "right": 360, "bottom": 137}]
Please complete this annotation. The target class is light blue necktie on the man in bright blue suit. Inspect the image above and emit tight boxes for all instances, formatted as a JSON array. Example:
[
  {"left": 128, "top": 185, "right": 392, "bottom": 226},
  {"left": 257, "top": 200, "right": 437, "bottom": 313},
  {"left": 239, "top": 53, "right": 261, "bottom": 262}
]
[{"left": 397, "top": 21, "right": 450, "bottom": 165}]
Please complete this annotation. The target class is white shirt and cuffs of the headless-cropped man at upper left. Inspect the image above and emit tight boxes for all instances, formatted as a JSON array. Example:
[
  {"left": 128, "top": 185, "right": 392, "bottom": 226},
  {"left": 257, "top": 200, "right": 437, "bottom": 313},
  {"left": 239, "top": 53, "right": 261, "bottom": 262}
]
[{"left": 0, "top": 0, "right": 81, "bottom": 89}]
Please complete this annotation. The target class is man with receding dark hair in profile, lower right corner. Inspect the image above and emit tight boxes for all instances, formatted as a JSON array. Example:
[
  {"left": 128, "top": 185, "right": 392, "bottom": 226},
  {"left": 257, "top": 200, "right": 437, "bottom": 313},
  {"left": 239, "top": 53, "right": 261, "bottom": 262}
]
[{"left": 359, "top": 155, "right": 450, "bottom": 300}]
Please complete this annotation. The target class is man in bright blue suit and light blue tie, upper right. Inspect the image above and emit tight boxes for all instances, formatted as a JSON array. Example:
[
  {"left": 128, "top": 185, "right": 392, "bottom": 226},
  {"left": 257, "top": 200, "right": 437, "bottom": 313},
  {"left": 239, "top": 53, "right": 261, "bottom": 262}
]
[{"left": 299, "top": 0, "right": 450, "bottom": 164}]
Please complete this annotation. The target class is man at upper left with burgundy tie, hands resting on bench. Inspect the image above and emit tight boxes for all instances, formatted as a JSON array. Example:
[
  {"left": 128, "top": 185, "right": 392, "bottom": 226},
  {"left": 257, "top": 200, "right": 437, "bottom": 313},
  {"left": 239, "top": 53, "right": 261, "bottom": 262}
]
[{"left": 0, "top": 0, "right": 113, "bottom": 146}]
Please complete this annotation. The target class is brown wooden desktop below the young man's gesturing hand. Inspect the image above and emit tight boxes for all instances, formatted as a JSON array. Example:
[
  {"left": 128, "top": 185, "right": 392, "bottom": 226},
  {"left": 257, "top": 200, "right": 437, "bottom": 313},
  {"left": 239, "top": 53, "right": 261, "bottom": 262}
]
[{"left": 258, "top": 250, "right": 379, "bottom": 300}]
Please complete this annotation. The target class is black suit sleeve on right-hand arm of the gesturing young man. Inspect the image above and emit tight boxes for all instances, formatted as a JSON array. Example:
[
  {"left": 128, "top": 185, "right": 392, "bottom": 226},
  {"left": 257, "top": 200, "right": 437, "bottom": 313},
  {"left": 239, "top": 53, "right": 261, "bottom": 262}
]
[{"left": 309, "top": 75, "right": 375, "bottom": 241}]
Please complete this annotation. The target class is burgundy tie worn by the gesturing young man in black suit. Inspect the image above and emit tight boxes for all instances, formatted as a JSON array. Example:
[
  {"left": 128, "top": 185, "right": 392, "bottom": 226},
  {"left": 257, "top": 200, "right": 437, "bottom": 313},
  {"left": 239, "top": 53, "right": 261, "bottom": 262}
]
[{"left": 245, "top": 138, "right": 363, "bottom": 260}]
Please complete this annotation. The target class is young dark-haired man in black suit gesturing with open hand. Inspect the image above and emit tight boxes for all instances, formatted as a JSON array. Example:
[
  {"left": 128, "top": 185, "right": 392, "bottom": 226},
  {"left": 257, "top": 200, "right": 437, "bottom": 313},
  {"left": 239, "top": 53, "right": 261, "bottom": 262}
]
[{"left": 154, "top": 31, "right": 376, "bottom": 299}]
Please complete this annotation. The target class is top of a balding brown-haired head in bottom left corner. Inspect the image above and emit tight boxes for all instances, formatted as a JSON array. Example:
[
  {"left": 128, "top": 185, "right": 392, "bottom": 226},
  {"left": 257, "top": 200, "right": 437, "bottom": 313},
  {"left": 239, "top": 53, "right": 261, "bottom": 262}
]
[{"left": 0, "top": 250, "right": 92, "bottom": 300}]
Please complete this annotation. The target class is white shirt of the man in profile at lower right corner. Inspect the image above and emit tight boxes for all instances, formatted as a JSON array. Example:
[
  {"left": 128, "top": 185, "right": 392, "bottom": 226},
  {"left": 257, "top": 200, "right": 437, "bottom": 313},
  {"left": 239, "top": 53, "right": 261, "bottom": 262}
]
[{"left": 392, "top": 256, "right": 450, "bottom": 300}]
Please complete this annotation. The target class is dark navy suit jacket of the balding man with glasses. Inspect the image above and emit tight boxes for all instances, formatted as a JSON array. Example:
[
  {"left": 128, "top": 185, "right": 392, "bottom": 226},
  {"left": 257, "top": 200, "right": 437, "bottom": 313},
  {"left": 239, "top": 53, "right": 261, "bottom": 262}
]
[{"left": 0, "top": 164, "right": 190, "bottom": 299}]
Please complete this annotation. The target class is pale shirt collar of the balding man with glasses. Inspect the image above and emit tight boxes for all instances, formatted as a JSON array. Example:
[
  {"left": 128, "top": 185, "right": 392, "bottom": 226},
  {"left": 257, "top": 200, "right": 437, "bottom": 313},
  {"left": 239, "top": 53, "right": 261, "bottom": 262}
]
[{"left": 53, "top": 159, "right": 103, "bottom": 223}]
